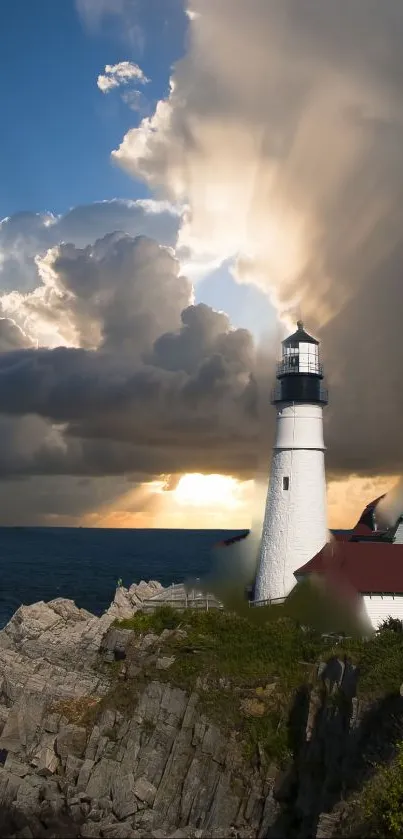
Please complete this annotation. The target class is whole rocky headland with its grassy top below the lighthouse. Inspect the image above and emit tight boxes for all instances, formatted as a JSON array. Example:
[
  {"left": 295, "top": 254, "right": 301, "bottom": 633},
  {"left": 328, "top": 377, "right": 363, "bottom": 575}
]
[{"left": 0, "top": 582, "right": 403, "bottom": 839}]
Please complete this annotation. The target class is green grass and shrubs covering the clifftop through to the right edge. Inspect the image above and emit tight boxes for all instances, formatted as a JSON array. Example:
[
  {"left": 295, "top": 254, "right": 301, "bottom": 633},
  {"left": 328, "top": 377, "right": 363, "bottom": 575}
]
[{"left": 109, "top": 606, "right": 403, "bottom": 763}]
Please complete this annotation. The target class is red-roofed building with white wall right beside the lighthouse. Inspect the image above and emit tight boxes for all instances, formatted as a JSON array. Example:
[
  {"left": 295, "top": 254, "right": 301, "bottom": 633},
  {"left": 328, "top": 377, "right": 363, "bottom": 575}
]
[{"left": 295, "top": 496, "right": 403, "bottom": 628}]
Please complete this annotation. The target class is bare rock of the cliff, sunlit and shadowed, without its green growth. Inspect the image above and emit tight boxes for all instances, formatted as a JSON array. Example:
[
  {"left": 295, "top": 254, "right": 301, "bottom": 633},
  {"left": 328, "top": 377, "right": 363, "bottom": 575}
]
[{"left": 0, "top": 583, "right": 403, "bottom": 839}]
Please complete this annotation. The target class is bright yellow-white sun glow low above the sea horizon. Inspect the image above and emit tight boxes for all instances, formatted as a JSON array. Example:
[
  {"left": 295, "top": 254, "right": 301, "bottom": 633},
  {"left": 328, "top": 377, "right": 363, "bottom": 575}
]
[{"left": 174, "top": 473, "right": 241, "bottom": 509}]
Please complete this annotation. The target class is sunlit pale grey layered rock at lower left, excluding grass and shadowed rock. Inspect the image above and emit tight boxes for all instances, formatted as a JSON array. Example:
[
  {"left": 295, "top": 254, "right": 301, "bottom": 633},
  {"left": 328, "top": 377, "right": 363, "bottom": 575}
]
[{"left": 0, "top": 583, "right": 276, "bottom": 839}]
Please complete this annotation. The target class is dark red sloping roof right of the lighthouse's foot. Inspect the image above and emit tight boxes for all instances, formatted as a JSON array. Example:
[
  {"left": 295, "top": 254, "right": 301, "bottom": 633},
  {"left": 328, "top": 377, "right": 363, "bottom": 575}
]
[{"left": 295, "top": 541, "right": 403, "bottom": 594}]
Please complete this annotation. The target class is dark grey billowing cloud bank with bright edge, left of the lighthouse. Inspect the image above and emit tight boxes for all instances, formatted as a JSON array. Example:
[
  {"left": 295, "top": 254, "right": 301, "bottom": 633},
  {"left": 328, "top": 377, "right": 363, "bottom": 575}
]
[{"left": 0, "top": 234, "right": 258, "bottom": 496}]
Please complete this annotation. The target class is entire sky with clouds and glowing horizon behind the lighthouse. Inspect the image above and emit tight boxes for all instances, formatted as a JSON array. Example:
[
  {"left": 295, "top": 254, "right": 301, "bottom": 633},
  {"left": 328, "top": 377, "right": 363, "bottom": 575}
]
[{"left": 0, "top": 0, "right": 403, "bottom": 528}]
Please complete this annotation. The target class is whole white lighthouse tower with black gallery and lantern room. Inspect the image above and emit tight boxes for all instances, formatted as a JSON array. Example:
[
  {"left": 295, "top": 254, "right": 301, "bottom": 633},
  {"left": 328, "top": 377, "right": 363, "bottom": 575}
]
[{"left": 255, "top": 321, "right": 328, "bottom": 604}]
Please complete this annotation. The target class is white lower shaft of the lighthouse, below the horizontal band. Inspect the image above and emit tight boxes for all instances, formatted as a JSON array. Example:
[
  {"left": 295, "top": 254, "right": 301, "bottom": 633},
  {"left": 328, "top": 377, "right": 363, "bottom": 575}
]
[{"left": 255, "top": 449, "right": 328, "bottom": 601}]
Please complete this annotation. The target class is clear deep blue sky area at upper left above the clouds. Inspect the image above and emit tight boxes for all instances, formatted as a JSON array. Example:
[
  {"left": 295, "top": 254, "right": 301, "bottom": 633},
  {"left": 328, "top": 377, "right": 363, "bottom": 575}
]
[{"left": 0, "top": 0, "right": 187, "bottom": 217}]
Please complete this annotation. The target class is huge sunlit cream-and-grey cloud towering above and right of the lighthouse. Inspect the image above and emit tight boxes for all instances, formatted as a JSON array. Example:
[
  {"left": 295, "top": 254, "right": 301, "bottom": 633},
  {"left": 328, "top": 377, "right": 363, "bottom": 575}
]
[{"left": 109, "top": 0, "right": 403, "bottom": 486}]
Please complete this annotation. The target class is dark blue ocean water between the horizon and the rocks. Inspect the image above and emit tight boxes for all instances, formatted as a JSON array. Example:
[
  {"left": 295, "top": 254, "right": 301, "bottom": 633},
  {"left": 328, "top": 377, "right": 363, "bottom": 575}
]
[{"left": 0, "top": 527, "right": 238, "bottom": 628}]
